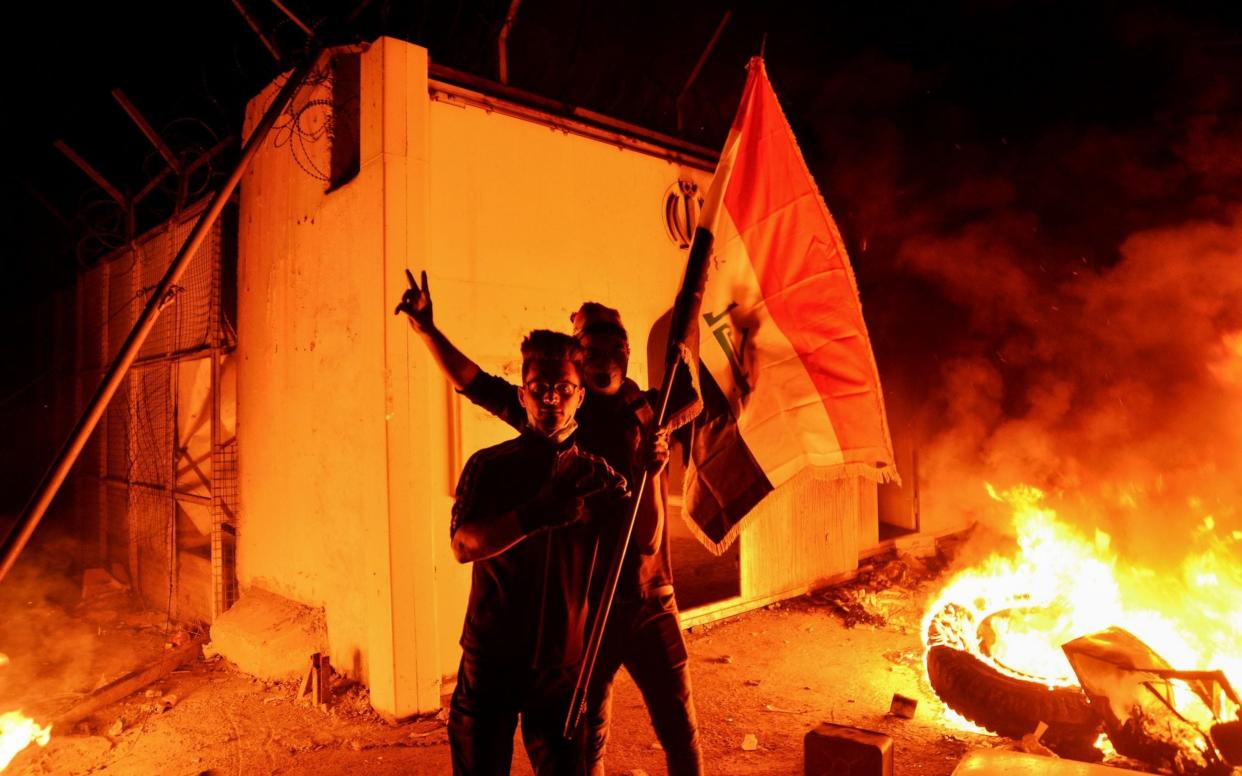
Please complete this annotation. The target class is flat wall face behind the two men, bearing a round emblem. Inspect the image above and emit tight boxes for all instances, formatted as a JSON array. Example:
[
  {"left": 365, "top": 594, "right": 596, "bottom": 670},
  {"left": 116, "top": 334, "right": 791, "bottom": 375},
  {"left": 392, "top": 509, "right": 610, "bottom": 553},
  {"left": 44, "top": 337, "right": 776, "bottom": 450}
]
[{"left": 428, "top": 84, "right": 710, "bottom": 661}]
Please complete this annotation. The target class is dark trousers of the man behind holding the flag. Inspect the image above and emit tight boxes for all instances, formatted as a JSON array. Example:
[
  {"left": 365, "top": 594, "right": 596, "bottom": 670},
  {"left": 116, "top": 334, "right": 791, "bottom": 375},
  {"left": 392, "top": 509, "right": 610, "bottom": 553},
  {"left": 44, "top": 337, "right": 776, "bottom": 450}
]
[{"left": 586, "top": 593, "right": 703, "bottom": 776}]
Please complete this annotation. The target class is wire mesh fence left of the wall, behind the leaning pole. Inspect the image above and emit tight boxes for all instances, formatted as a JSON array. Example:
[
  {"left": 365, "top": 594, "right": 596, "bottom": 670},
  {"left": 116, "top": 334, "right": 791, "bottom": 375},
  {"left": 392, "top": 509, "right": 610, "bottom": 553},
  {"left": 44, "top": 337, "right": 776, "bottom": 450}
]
[{"left": 75, "top": 201, "right": 237, "bottom": 620}]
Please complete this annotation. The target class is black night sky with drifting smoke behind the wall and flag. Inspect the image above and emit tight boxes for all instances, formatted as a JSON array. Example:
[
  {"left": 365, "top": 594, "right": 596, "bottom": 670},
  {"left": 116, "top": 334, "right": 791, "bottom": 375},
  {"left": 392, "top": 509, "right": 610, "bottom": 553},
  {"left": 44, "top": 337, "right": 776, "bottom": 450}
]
[{"left": 7, "top": 0, "right": 1242, "bottom": 551}]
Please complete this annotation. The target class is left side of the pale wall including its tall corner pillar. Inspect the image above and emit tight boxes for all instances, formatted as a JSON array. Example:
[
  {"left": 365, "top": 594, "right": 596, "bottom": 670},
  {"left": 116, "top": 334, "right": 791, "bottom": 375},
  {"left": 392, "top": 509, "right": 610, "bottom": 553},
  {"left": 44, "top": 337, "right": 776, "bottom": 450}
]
[{"left": 237, "top": 40, "right": 443, "bottom": 716}]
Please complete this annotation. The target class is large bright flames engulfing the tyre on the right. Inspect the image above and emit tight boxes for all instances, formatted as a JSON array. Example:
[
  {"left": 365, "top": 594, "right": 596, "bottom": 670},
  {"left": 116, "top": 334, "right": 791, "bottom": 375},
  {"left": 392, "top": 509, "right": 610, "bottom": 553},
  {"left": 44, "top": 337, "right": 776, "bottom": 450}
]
[{"left": 923, "top": 485, "right": 1242, "bottom": 724}]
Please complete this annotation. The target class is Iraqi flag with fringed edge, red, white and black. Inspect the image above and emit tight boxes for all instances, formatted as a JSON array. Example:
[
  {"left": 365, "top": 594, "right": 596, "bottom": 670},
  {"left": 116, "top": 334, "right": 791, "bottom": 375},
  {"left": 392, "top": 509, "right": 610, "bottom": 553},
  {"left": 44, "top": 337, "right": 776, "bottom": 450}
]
[{"left": 671, "top": 57, "right": 897, "bottom": 553}]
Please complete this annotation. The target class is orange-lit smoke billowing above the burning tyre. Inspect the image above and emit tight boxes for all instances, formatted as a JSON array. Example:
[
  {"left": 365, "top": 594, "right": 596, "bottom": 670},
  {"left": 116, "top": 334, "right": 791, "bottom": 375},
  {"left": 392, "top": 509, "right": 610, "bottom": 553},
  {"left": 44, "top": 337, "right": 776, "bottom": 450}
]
[{"left": 902, "top": 207, "right": 1242, "bottom": 551}]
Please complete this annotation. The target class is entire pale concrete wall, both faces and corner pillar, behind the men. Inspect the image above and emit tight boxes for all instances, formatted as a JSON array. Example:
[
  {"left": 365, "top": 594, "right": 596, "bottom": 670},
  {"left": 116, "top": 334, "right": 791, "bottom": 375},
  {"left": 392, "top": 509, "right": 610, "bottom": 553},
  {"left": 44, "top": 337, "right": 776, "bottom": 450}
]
[{"left": 237, "top": 38, "right": 884, "bottom": 716}]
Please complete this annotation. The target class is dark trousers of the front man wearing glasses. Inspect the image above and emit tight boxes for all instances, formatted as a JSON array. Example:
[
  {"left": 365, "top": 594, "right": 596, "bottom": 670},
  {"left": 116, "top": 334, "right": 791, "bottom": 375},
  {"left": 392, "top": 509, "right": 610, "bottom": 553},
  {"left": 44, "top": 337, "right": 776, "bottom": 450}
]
[{"left": 448, "top": 653, "right": 584, "bottom": 776}]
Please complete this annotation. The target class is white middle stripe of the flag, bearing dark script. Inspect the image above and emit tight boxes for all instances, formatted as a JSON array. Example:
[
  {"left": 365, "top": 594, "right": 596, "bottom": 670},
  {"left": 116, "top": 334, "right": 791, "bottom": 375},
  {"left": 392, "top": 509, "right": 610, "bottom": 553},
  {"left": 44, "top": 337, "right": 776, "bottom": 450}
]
[{"left": 699, "top": 209, "right": 845, "bottom": 487}]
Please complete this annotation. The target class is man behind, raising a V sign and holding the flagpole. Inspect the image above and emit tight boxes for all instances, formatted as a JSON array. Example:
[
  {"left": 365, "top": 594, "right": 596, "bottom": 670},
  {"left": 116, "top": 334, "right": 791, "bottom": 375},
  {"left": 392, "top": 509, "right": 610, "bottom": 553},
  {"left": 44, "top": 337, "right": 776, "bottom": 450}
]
[{"left": 397, "top": 285, "right": 703, "bottom": 776}]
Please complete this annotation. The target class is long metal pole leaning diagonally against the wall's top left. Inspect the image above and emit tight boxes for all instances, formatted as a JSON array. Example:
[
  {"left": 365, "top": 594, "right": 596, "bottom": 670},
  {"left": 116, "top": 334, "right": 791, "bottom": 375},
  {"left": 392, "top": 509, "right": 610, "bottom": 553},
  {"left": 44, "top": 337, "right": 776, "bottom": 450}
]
[{"left": 0, "top": 47, "right": 319, "bottom": 581}]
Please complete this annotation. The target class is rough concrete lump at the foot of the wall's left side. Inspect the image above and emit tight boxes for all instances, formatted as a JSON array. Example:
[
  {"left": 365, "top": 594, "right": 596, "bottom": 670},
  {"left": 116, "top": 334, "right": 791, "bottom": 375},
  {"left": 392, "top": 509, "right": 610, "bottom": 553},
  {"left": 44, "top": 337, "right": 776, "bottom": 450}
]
[{"left": 211, "top": 587, "right": 328, "bottom": 680}]
